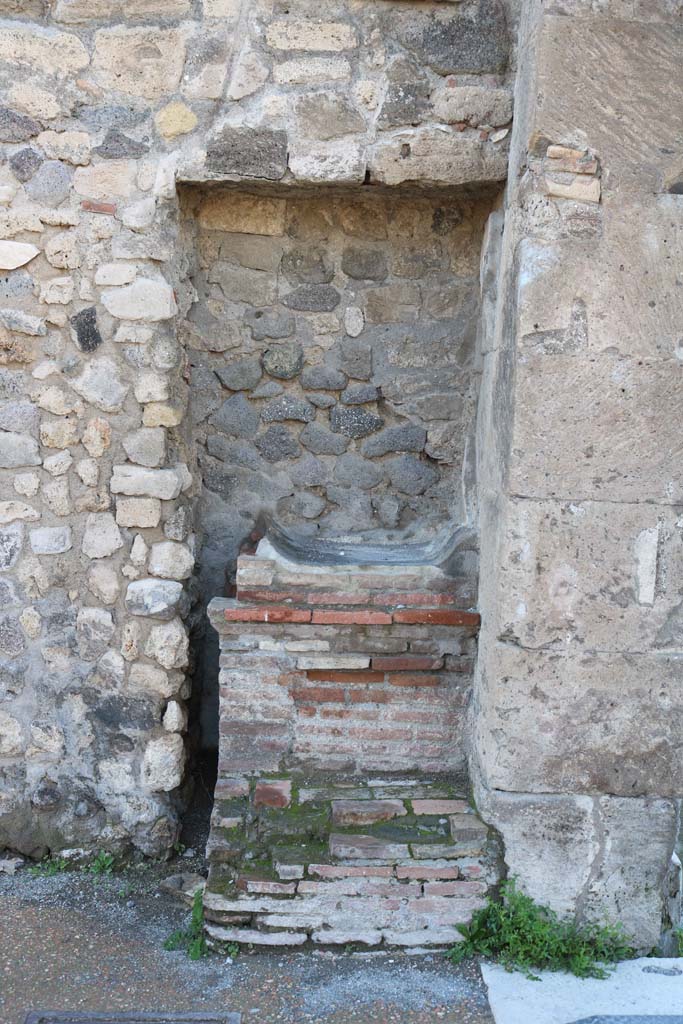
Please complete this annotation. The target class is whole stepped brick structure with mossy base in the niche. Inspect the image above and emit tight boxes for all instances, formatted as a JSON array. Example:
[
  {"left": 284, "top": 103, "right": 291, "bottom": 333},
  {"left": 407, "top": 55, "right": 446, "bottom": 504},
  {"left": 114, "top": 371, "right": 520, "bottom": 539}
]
[{"left": 204, "top": 544, "right": 497, "bottom": 947}]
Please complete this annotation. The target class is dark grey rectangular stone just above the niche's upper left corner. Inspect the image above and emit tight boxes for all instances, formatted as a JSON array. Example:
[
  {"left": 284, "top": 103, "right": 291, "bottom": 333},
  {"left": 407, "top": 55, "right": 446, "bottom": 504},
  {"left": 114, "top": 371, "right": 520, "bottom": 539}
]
[{"left": 206, "top": 125, "right": 287, "bottom": 181}]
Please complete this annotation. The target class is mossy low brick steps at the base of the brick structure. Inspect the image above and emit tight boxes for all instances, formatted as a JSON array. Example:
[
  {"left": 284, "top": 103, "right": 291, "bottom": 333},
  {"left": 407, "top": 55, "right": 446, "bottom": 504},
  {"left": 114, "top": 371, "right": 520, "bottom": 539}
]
[{"left": 204, "top": 775, "right": 495, "bottom": 946}]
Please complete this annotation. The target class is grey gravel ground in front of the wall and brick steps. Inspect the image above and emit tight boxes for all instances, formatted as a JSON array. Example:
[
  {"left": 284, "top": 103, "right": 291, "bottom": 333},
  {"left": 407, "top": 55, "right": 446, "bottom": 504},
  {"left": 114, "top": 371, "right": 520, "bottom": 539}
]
[{"left": 0, "top": 858, "right": 493, "bottom": 1024}]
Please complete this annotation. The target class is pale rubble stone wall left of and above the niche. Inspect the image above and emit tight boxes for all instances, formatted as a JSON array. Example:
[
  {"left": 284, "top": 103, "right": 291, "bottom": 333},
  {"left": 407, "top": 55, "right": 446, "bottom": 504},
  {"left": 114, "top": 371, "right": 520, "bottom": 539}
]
[{"left": 0, "top": 0, "right": 512, "bottom": 854}]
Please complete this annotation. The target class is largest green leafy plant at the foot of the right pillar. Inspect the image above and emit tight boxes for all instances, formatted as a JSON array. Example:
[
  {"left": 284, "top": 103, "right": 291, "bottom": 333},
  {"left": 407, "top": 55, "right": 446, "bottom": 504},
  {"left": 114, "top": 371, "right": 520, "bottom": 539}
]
[{"left": 447, "top": 881, "right": 635, "bottom": 980}]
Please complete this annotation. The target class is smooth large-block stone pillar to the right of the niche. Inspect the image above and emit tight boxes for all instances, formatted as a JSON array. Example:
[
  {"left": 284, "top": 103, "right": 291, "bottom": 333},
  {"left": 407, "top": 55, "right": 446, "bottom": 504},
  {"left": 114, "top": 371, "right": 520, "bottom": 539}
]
[{"left": 471, "top": 0, "right": 683, "bottom": 950}]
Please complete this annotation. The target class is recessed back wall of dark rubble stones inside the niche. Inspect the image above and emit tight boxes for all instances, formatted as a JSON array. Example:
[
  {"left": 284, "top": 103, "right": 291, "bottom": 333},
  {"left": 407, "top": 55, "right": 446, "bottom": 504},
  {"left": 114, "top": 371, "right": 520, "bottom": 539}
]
[{"left": 187, "top": 186, "right": 488, "bottom": 552}]
